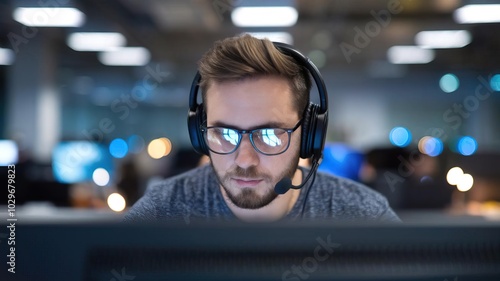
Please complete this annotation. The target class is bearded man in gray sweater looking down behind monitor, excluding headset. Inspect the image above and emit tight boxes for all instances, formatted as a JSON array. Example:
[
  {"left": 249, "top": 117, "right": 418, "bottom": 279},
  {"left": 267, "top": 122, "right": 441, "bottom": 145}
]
[{"left": 125, "top": 35, "right": 399, "bottom": 222}]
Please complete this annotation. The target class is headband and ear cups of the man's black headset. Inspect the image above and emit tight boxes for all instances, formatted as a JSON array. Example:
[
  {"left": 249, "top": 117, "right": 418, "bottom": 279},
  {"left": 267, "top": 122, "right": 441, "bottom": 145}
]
[{"left": 187, "top": 42, "right": 328, "bottom": 162}]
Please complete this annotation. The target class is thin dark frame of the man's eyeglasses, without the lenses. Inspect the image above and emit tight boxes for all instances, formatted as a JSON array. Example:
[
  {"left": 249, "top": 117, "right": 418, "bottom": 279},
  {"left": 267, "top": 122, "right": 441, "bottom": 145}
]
[{"left": 200, "top": 118, "right": 304, "bottom": 156}]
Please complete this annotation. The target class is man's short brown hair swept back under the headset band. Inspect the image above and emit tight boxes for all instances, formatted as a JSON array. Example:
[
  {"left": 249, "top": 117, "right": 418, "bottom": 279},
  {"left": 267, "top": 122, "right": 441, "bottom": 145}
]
[{"left": 198, "top": 34, "right": 311, "bottom": 116}]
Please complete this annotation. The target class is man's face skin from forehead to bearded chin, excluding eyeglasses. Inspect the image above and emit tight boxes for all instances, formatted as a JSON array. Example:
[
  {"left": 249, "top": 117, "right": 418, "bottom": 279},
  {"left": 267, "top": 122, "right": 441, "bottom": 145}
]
[{"left": 206, "top": 77, "right": 300, "bottom": 209}]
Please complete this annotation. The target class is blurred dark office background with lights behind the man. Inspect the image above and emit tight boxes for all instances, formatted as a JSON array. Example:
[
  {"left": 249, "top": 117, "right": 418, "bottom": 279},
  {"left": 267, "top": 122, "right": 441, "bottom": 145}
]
[{"left": 0, "top": 0, "right": 500, "bottom": 217}]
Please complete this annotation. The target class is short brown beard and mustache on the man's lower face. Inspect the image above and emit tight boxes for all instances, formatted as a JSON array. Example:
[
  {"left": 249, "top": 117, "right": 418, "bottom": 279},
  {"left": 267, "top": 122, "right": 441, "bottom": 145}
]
[{"left": 210, "top": 152, "right": 299, "bottom": 209}]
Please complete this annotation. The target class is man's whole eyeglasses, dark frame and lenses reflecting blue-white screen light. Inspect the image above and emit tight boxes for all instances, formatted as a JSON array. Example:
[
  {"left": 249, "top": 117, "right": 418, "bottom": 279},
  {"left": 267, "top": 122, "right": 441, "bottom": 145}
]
[{"left": 201, "top": 119, "right": 302, "bottom": 155}]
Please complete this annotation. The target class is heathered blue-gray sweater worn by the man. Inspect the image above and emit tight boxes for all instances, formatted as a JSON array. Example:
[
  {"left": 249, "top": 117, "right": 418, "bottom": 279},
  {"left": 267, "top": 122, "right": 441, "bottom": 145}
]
[{"left": 124, "top": 165, "right": 400, "bottom": 223}]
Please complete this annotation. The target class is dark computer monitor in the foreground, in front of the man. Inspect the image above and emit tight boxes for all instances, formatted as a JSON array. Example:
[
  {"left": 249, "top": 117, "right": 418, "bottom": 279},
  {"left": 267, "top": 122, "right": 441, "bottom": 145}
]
[{"left": 0, "top": 221, "right": 500, "bottom": 281}]
